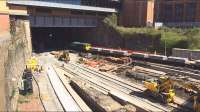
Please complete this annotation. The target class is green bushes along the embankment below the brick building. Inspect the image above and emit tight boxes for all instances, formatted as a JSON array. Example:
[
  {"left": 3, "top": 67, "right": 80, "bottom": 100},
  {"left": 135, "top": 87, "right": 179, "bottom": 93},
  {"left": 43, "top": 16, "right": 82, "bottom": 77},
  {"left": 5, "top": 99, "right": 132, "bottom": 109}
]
[{"left": 104, "top": 14, "right": 200, "bottom": 49}]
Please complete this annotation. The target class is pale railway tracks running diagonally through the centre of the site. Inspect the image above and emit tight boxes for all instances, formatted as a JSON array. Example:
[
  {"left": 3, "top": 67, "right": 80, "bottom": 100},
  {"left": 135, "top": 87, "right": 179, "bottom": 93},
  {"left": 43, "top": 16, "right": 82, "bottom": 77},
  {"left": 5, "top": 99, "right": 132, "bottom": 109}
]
[{"left": 57, "top": 63, "right": 186, "bottom": 111}]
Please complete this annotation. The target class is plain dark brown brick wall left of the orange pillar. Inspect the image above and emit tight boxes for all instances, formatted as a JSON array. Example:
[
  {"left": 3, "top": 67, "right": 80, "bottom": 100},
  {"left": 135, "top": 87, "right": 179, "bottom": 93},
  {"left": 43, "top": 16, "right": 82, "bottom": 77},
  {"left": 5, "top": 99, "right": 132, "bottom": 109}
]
[{"left": 119, "top": 0, "right": 147, "bottom": 27}]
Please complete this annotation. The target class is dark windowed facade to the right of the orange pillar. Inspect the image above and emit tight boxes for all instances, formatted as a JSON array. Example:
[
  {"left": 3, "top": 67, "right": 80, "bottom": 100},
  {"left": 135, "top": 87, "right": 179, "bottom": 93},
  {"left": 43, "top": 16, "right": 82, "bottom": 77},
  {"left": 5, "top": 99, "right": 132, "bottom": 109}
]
[{"left": 154, "top": 0, "right": 200, "bottom": 26}]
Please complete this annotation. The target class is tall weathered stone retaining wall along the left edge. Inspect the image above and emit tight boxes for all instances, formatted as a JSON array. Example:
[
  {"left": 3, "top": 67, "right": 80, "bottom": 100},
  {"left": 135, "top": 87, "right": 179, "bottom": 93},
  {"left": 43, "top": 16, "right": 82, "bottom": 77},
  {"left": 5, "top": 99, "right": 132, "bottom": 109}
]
[{"left": 0, "top": 19, "right": 31, "bottom": 111}]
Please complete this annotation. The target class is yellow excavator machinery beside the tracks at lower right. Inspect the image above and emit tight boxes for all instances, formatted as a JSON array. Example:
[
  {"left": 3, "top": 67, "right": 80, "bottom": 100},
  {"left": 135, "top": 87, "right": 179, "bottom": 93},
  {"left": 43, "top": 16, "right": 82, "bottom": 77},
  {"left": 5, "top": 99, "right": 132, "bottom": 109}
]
[{"left": 144, "top": 77, "right": 200, "bottom": 112}]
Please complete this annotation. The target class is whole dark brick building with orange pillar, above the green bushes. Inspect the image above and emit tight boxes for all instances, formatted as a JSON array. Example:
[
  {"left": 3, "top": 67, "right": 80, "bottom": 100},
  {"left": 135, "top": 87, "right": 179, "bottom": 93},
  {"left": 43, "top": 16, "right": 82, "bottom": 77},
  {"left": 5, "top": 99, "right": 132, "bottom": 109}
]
[{"left": 120, "top": 0, "right": 200, "bottom": 27}]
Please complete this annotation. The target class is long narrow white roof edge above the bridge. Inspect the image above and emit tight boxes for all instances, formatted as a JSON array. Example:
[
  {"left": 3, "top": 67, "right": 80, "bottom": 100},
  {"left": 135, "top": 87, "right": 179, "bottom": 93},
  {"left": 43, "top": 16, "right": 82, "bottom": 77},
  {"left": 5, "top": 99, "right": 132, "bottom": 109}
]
[{"left": 7, "top": 0, "right": 117, "bottom": 13}]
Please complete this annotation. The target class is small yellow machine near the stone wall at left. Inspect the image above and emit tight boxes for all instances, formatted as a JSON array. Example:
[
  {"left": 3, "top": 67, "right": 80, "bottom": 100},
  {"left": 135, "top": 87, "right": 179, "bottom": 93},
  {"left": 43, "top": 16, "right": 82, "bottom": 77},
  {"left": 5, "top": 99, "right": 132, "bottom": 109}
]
[{"left": 26, "top": 57, "right": 42, "bottom": 72}]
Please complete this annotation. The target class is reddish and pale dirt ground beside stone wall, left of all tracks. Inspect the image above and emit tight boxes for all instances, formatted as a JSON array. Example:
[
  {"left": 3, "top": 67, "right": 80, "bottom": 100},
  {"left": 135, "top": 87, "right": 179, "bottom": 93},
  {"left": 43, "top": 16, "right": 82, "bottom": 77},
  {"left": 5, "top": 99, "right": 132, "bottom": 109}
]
[{"left": 17, "top": 55, "right": 63, "bottom": 111}]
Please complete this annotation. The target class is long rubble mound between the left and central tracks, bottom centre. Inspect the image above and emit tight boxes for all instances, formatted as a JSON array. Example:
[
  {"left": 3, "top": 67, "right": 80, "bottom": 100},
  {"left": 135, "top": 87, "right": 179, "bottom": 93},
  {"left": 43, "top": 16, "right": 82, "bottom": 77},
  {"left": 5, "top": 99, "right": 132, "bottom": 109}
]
[{"left": 69, "top": 79, "right": 136, "bottom": 112}]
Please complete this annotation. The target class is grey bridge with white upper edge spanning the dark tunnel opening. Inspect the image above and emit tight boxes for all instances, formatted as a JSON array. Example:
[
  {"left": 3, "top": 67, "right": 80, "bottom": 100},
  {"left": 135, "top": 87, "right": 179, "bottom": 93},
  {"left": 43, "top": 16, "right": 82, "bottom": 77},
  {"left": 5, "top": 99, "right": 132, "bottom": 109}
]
[{"left": 7, "top": 0, "right": 117, "bottom": 27}]
